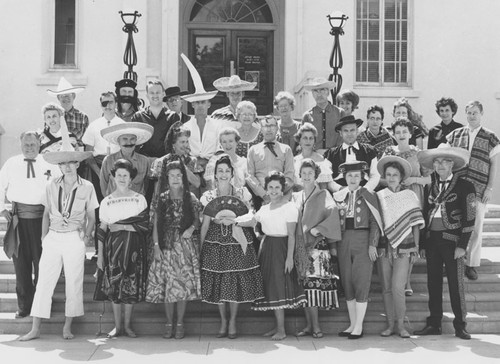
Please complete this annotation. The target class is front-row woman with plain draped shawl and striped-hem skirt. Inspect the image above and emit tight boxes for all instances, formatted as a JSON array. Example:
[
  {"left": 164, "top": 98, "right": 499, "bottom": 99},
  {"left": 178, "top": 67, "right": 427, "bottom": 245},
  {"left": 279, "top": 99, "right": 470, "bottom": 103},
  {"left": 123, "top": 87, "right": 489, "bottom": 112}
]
[{"left": 292, "top": 159, "right": 342, "bottom": 339}]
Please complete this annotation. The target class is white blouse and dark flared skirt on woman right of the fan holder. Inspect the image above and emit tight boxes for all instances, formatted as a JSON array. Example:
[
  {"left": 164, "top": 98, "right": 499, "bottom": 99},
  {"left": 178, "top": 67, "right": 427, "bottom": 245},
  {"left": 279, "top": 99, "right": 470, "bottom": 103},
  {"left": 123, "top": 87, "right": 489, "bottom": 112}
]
[{"left": 252, "top": 202, "right": 307, "bottom": 311}]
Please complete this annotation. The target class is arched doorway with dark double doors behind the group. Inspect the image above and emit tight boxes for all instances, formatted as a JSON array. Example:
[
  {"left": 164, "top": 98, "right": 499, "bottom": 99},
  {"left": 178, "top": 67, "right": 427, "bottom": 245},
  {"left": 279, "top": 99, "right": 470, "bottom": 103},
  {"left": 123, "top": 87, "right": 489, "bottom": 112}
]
[{"left": 181, "top": 0, "right": 284, "bottom": 115}]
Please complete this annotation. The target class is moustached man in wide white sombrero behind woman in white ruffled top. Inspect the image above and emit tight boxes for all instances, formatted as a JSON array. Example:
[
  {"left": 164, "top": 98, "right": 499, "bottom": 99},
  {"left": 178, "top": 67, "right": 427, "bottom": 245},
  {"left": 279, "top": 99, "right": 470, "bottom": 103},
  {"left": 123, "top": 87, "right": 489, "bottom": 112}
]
[{"left": 99, "top": 122, "right": 154, "bottom": 197}]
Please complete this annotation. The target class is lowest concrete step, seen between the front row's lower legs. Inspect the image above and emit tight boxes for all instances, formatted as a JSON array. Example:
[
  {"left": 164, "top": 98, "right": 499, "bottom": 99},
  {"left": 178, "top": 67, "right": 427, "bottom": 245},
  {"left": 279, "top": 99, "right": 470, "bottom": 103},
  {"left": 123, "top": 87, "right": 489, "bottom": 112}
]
[{"left": 0, "top": 309, "right": 500, "bottom": 337}]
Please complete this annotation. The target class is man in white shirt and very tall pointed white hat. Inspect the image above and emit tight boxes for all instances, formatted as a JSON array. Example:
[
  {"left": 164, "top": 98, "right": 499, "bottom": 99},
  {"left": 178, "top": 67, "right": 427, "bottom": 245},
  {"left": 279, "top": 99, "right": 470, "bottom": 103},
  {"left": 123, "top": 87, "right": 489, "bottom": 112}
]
[{"left": 181, "top": 54, "right": 226, "bottom": 179}]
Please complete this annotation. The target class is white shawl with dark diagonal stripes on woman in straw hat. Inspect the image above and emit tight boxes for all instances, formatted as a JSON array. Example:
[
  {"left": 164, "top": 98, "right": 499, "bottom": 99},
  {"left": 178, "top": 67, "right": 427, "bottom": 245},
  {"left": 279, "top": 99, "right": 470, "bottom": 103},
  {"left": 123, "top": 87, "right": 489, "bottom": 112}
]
[{"left": 377, "top": 188, "right": 425, "bottom": 253}]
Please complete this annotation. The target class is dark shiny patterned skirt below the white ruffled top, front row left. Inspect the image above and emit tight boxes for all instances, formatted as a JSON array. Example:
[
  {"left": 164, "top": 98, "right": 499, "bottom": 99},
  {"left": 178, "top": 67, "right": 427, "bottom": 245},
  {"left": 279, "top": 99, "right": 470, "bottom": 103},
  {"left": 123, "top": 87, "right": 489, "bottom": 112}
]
[{"left": 96, "top": 231, "right": 148, "bottom": 304}]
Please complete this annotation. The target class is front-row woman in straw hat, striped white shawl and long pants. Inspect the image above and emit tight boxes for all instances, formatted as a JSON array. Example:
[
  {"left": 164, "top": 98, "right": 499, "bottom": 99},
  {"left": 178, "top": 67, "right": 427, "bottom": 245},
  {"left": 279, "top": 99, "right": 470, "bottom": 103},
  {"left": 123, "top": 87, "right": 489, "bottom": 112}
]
[{"left": 377, "top": 156, "right": 424, "bottom": 338}]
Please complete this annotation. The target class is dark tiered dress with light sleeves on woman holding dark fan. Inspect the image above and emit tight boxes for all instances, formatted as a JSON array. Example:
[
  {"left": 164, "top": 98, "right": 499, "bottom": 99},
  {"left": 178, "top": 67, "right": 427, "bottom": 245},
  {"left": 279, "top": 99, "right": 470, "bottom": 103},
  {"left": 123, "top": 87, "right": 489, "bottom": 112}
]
[{"left": 200, "top": 188, "right": 264, "bottom": 304}]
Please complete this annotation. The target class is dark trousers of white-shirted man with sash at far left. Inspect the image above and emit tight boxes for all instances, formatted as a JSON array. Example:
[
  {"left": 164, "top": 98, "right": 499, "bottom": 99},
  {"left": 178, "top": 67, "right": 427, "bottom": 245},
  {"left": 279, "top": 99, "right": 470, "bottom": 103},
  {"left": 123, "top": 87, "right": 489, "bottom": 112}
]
[{"left": 12, "top": 218, "right": 42, "bottom": 314}]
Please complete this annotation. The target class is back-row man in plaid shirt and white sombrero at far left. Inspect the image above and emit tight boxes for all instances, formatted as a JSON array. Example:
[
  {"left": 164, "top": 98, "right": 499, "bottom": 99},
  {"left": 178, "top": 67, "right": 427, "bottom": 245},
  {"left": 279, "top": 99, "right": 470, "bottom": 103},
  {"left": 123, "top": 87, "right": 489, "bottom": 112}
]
[{"left": 47, "top": 77, "right": 89, "bottom": 149}]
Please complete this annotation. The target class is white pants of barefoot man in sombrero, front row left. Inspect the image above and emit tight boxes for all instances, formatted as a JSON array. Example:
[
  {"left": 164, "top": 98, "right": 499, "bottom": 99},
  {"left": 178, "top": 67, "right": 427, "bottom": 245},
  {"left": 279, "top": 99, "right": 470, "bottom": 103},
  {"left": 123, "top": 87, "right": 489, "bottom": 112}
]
[{"left": 31, "top": 230, "right": 85, "bottom": 318}]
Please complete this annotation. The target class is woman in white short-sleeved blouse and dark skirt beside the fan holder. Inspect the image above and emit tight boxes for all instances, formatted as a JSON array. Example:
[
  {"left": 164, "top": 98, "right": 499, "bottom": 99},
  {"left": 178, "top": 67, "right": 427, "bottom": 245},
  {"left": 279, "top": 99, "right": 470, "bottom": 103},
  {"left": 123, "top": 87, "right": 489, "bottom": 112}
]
[{"left": 249, "top": 172, "right": 307, "bottom": 340}]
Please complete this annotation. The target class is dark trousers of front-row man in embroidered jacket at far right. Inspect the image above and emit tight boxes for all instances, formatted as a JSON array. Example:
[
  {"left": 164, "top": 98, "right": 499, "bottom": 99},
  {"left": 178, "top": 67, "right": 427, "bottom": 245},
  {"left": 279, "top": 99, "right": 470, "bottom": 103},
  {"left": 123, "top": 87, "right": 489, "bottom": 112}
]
[{"left": 425, "top": 231, "right": 467, "bottom": 330}]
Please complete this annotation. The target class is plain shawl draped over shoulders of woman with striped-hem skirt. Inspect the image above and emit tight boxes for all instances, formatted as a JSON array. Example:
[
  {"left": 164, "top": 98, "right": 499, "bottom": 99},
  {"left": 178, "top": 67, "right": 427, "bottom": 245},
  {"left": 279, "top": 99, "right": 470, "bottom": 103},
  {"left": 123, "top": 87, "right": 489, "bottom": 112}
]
[{"left": 293, "top": 186, "right": 342, "bottom": 279}]
